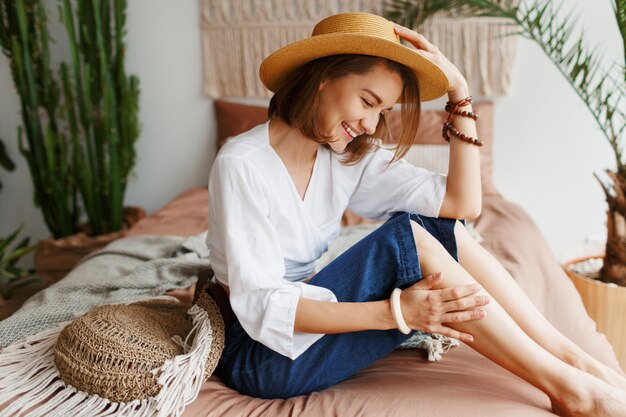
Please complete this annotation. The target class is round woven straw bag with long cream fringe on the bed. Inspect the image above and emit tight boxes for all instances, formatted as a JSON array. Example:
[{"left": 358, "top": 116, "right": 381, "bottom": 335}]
[{"left": 0, "top": 284, "right": 225, "bottom": 417}]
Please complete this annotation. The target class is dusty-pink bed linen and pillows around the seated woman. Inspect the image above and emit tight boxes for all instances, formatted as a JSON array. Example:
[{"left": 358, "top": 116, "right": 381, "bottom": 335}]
[{"left": 0, "top": 101, "right": 619, "bottom": 417}]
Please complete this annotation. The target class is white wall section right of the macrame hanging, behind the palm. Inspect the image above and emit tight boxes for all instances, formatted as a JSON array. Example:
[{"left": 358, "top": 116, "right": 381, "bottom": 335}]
[{"left": 494, "top": 0, "right": 624, "bottom": 255}]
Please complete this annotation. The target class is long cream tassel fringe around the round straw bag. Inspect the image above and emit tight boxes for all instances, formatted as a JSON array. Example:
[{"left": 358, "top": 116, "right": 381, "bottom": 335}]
[{"left": 0, "top": 305, "right": 213, "bottom": 417}]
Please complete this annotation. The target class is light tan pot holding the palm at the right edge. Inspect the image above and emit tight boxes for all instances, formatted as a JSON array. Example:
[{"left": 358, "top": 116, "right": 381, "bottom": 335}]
[{"left": 563, "top": 256, "right": 626, "bottom": 369}]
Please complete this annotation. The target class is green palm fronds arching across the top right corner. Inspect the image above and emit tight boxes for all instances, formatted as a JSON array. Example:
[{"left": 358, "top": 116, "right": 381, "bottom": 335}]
[{"left": 385, "top": 0, "right": 626, "bottom": 167}]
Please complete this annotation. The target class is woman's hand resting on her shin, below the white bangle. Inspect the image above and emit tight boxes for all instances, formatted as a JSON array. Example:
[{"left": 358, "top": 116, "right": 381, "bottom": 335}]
[{"left": 400, "top": 272, "right": 489, "bottom": 342}]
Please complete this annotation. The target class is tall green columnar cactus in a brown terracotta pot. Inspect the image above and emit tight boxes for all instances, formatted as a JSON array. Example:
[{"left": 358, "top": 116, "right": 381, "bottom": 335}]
[{"left": 0, "top": 0, "right": 145, "bottom": 281}]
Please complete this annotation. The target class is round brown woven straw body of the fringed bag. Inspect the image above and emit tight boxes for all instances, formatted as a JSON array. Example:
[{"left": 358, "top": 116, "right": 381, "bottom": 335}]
[{"left": 54, "top": 290, "right": 224, "bottom": 402}]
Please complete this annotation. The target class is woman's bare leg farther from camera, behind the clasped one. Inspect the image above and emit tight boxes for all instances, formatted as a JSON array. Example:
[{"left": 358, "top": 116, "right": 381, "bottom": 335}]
[{"left": 455, "top": 222, "right": 626, "bottom": 390}]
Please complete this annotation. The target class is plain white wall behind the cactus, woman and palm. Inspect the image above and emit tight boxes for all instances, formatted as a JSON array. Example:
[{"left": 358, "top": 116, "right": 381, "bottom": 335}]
[{"left": 0, "top": 0, "right": 622, "bottom": 263}]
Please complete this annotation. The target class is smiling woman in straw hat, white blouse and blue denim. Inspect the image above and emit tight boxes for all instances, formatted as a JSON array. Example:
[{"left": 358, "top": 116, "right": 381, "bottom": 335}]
[{"left": 207, "top": 13, "right": 626, "bottom": 416}]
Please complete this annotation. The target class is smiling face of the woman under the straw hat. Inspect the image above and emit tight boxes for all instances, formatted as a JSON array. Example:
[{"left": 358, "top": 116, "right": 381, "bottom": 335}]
[{"left": 315, "top": 65, "right": 403, "bottom": 153}]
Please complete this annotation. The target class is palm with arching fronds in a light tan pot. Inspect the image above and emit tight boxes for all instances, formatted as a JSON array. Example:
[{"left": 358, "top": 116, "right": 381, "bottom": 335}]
[{"left": 387, "top": 0, "right": 626, "bottom": 368}]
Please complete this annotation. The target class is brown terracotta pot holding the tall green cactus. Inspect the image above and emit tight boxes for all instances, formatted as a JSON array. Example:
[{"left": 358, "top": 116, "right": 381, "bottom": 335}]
[{"left": 35, "top": 207, "right": 146, "bottom": 285}]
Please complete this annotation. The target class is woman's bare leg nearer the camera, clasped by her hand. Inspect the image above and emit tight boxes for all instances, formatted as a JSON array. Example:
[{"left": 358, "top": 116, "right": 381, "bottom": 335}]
[{"left": 411, "top": 221, "right": 626, "bottom": 417}]
